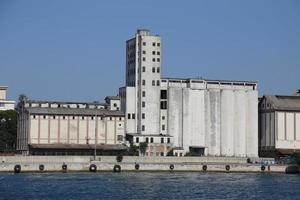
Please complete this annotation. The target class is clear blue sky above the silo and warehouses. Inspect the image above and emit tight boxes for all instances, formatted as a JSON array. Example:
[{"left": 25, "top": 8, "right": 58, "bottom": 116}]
[{"left": 0, "top": 0, "right": 300, "bottom": 101}]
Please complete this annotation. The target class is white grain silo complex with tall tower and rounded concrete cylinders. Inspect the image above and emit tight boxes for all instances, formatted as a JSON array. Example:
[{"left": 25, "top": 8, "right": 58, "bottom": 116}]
[{"left": 119, "top": 30, "right": 258, "bottom": 157}]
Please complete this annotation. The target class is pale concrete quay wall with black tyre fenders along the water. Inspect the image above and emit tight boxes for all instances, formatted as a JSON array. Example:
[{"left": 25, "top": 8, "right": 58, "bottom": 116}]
[{"left": 0, "top": 156, "right": 287, "bottom": 172}]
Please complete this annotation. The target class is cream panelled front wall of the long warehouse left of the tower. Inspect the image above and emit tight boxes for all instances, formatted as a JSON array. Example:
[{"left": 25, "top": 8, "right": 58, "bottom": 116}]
[{"left": 29, "top": 115, "right": 125, "bottom": 144}]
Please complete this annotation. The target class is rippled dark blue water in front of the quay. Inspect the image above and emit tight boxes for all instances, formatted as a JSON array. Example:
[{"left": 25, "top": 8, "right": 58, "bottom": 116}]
[{"left": 0, "top": 172, "right": 300, "bottom": 200}]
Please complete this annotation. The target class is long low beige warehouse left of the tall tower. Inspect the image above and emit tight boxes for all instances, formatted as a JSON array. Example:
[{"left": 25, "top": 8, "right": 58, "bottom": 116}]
[{"left": 17, "top": 98, "right": 126, "bottom": 155}]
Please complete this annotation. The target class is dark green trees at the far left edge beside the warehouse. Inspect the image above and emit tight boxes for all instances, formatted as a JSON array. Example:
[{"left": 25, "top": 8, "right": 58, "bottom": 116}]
[{"left": 0, "top": 110, "right": 17, "bottom": 152}]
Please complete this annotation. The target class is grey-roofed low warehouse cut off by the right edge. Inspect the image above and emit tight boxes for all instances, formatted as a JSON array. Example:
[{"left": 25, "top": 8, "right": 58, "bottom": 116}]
[{"left": 259, "top": 91, "right": 300, "bottom": 156}]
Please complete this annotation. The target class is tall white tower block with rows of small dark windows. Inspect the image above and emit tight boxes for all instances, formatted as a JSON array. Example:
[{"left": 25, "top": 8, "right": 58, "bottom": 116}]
[{"left": 121, "top": 29, "right": 161, "bottom": 135}]
